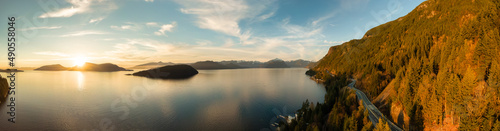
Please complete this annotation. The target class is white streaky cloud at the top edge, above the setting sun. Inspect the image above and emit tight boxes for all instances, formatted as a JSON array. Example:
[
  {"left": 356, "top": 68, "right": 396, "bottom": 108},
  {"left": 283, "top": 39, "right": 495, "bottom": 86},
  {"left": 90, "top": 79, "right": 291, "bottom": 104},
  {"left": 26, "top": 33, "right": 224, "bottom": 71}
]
[{"left": 38, "top": 0, "right": 117, "bottom": 18}]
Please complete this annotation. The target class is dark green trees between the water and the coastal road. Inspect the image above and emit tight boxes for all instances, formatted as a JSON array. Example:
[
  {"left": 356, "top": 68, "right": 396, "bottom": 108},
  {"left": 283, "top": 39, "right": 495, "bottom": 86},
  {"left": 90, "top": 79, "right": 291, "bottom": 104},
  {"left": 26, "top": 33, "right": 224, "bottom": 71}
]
[{"left": 280, "top": 73, "right": 373, "bottom": 131}]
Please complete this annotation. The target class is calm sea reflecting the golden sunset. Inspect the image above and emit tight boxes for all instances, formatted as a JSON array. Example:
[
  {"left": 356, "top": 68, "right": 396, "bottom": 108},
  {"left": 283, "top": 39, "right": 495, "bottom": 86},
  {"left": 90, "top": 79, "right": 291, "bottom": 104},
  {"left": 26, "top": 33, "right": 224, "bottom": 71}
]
[{"left": 0, "top": 68, "right": 325, "bottom": 130}]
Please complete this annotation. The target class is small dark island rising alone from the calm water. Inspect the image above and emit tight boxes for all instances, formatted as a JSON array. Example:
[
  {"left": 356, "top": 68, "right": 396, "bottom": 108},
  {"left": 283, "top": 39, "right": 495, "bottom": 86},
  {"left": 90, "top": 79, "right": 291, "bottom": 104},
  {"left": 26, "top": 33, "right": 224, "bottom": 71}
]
[{"left": 132, "top": 65, "right": 198, "bottom": 79}]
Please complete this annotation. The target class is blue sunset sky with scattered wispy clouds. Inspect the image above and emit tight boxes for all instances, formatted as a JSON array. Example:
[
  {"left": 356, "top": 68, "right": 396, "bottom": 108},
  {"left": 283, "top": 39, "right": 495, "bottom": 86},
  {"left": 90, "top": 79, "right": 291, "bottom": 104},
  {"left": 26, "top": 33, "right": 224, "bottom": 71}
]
[{"left": 0, "top": 0, "right": 423, "bottom": 68}]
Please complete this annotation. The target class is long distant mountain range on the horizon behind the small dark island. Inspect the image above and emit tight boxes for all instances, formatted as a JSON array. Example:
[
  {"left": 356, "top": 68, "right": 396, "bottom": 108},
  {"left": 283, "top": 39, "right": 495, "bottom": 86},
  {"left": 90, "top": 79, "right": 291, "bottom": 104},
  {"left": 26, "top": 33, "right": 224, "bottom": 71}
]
[{"left": 131, "top": 58, "right": 314, "bottom": 70}]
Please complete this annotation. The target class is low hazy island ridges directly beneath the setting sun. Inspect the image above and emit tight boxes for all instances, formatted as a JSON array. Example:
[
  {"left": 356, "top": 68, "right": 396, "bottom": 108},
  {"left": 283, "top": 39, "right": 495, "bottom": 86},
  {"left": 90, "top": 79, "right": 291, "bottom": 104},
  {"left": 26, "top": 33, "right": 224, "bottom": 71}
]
[{"left": 35, "top": 62, "right": 131, "bottom": 72}]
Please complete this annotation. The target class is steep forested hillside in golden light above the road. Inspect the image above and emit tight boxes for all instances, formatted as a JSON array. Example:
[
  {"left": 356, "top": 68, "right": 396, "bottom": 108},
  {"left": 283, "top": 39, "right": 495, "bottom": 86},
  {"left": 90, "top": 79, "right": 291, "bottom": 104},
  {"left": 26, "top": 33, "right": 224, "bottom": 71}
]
[{"left": 313, "top": 0, "right": 500, "bottom": 130}]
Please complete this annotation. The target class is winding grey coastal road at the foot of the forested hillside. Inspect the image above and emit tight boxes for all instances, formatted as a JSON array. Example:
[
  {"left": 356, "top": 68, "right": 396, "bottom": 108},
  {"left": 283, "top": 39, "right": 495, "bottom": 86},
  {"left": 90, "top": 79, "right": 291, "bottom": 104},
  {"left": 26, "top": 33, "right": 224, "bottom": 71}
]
[{"left": 347, "top": 79, "right": 402, "bottom": 131}]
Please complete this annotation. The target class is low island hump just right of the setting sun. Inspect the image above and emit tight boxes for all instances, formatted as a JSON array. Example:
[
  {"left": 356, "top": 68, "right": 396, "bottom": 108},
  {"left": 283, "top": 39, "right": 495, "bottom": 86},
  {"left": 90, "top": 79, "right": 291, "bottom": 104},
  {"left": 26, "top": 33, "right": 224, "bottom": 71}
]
[{"left": 68, "top": 62, "right": 131, "bottom": 72}]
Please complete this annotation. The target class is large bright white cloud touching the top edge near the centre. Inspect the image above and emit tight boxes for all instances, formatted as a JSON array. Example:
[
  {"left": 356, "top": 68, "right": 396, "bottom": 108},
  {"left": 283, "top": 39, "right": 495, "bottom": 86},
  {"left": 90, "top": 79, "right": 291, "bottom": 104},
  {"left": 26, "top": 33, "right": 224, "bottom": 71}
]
[{"left": 177, "top": 0, "right": 274, "bottom": 37}]
